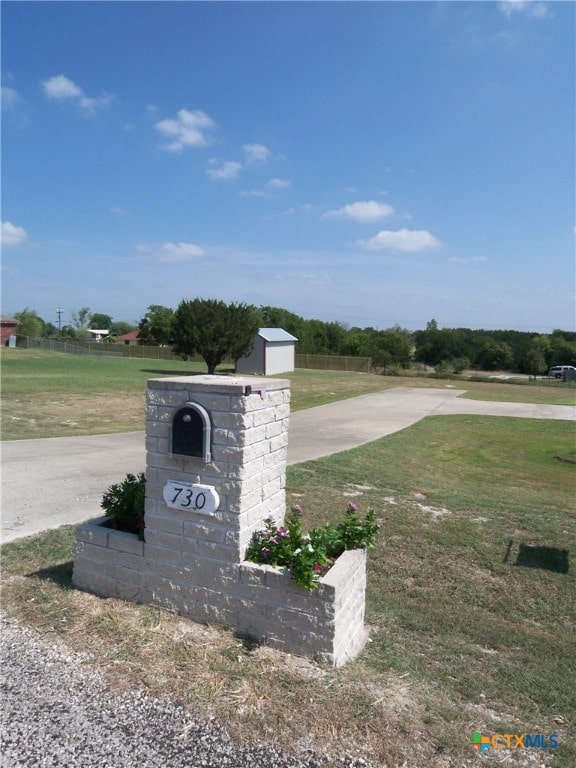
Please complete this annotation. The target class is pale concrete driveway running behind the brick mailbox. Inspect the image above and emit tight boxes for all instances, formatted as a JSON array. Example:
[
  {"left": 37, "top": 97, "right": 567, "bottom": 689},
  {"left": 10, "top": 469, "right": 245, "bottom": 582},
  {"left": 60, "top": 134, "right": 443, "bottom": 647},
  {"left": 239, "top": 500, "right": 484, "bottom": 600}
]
[{"left": 0, "top": 387, "right": 576, "bottom": 542}]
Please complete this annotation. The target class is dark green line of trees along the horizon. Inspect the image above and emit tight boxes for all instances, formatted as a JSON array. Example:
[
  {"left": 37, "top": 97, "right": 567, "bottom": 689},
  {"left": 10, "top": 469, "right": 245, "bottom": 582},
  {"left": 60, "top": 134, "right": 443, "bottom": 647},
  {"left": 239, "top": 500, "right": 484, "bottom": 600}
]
[{"left": 14, "top": 298, "right": 576, "bottom": 374}]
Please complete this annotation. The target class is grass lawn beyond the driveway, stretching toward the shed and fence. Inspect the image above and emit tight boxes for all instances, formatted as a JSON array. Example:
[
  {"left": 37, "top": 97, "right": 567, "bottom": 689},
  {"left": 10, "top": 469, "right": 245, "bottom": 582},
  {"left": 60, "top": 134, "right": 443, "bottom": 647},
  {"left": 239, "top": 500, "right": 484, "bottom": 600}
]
[{"left": 0, "top": 349, "right": 576, "bottom": 440}]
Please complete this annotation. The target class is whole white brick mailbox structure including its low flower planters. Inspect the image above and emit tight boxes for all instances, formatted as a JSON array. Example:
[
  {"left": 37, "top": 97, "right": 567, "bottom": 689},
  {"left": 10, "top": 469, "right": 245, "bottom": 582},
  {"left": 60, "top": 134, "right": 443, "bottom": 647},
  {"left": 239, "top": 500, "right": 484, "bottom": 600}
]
[{"left": 73, "top": 375, "right": 367, "bottom": 665}]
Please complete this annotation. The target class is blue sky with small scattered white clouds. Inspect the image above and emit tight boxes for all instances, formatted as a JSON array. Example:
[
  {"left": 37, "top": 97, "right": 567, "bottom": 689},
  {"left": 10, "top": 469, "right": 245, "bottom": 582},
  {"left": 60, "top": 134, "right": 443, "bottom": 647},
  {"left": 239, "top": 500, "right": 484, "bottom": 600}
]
[{"left": 1, "top": 0, "right": 575, "bottom": 332}]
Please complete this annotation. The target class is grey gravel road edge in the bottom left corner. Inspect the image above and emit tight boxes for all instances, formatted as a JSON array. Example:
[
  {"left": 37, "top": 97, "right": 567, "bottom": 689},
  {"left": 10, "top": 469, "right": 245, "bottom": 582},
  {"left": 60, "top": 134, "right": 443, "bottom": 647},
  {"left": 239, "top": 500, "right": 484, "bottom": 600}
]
[{"left": 0, "top": 616, "right": 376, "bottom": 768}]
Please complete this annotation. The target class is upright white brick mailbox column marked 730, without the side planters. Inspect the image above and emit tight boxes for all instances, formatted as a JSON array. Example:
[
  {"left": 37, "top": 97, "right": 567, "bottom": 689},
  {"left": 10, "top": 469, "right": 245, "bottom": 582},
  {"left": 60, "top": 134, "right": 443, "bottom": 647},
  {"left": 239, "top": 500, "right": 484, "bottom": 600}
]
[{"left": 145, "top": 376, "right": 290, "bottom": 623}]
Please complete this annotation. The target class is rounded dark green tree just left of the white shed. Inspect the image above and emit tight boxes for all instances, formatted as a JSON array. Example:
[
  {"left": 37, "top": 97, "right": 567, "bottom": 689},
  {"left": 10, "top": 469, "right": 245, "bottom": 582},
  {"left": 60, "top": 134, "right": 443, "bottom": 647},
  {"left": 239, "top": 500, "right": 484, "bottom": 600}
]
[{"left": 173, "top": 299, "right": 261, "bottom": 374}]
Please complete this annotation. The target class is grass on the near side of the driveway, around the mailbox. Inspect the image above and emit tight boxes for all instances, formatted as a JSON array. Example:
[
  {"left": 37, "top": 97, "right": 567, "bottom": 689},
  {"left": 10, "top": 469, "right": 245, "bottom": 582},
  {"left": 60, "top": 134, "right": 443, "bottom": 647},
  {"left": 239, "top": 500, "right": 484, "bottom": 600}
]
[{"left": 2, "top": 416, "right": 576, "bottom": 768}]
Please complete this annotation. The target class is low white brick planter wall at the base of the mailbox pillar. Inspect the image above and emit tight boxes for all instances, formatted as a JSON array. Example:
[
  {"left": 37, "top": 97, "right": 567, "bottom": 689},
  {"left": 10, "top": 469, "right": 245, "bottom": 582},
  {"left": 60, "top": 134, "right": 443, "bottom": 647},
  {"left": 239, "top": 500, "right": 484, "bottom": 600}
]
[{"left": 74, "top": 517, "right": 368, "bottom": 666}]
